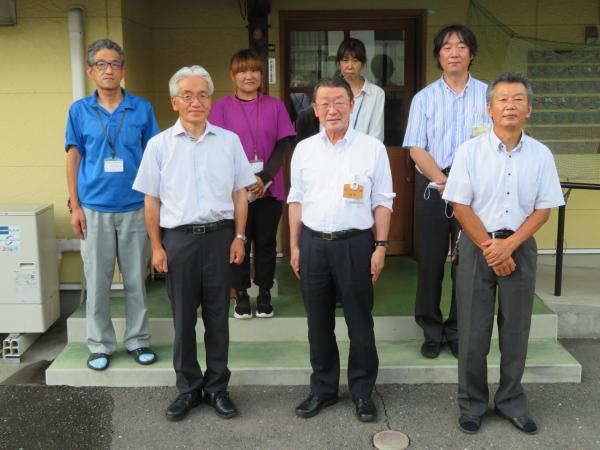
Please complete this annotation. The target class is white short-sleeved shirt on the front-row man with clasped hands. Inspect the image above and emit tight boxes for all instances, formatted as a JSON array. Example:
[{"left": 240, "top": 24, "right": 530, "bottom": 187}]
[{"left": 443, "top": 130, "right": 565, "bottom": 232}]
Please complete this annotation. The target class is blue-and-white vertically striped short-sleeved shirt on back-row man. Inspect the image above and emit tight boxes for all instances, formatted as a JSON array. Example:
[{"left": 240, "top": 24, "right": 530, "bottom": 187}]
[{"left": 402, "top": 75, "right": 491, "bottom": 169}]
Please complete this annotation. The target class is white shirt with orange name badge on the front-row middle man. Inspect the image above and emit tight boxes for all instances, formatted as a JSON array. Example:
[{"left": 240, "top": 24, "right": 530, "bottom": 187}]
[{"left": 287, "top": 128, "right": 396, "bottom": 232}]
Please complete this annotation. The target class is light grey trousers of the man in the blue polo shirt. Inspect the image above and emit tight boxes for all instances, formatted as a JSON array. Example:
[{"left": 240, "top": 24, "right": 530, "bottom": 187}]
[{"left": 81, "top": 208, "right": 150, "bottom": 355}]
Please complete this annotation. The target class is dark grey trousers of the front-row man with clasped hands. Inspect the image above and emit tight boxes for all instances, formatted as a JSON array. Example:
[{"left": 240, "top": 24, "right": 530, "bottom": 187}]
[{"left": 456, "top": 234, "right": 537, "bottom": 417}]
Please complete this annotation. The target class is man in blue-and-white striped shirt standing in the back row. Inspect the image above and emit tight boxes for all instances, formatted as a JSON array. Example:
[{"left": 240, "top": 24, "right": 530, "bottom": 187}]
[{"left": 403, "top": 25, "right": 490, "bottom": 358}]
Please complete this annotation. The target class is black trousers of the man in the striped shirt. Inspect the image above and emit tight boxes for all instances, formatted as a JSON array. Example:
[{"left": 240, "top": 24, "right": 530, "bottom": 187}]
[{"left": 415, "top": 173, "right": 460, "bottom": 342}]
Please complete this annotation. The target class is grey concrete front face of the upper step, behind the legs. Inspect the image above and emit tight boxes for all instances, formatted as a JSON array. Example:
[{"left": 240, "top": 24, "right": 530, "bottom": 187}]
[{"left": 67, "top": 313, "right": 558, "bottom": 343}]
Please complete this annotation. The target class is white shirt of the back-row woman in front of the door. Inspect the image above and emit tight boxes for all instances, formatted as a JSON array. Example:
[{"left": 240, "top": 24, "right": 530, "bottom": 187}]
[{"left": 350, "top": 80, "right": 385, "bottom": 142}]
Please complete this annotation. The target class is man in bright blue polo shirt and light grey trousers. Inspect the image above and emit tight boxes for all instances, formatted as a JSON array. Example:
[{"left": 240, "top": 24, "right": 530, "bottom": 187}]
[{"left": 65, "top": 39, "right": 160, "bottom": 370}]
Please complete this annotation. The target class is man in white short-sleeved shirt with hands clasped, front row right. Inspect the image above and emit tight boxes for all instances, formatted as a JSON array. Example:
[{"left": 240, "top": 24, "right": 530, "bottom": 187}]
[{"left": 443, "top": 72, "right": 564, "bottom": 434}]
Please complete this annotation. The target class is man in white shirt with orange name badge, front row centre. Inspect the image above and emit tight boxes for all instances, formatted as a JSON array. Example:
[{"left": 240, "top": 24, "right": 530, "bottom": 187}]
[{"left": 288, "top": 78, "right": 395, "bottom": 422}]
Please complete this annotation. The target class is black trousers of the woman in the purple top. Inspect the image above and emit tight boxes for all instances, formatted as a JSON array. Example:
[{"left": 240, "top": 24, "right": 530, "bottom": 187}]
[{"left": 231, "top": 197, "right": 282, "bottom": 290}]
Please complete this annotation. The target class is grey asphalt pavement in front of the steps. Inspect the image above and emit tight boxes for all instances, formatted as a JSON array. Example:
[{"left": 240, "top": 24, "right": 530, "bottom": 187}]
[{"left": 0, "top": 339, "right": 600, "bottom": 450}]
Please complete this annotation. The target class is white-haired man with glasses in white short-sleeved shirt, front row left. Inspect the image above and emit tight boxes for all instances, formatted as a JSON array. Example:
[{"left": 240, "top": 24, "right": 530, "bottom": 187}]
[{"left": 133, "top": 66, "right": 255, "bottom": 420}]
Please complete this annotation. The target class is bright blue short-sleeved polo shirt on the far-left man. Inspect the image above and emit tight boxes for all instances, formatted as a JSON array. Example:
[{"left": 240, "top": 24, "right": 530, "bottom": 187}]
[{"left": 65, "top": 89, "right": 160, "bottom": 212}]
